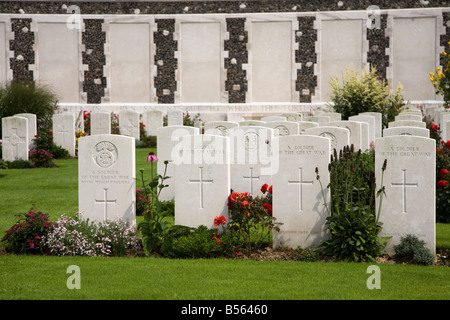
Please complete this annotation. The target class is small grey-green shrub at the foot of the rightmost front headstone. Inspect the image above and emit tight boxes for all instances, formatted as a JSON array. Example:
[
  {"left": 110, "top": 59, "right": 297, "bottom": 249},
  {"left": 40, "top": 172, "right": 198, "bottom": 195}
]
[{"left": 394, "top": 234, "right": 434, "bottom": 265}]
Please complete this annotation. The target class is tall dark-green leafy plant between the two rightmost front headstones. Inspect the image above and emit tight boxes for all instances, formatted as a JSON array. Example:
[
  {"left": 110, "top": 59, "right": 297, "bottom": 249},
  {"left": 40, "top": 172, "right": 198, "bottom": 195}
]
[{"left": 316, "top": 146, "right": 388, "bottom": 262}]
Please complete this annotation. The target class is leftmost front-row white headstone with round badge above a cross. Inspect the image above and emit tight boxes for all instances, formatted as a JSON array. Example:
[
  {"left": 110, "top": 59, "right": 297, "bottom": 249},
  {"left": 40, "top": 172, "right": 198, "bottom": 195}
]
[{"left": 78, "top": 134, "right": 136, "bottom": 224}]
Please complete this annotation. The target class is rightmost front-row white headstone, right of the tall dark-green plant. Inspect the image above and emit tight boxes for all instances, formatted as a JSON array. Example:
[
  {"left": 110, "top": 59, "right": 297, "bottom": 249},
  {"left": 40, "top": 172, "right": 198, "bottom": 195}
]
[{"left": 375, "top": 136, "right": 436, "bottom": 254}]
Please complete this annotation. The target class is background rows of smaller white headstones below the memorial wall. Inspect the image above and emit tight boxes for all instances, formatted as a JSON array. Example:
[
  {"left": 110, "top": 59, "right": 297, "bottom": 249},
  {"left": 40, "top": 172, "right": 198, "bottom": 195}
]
[{"left": 2, "top": 108, "right": 450, "bottom": 161}]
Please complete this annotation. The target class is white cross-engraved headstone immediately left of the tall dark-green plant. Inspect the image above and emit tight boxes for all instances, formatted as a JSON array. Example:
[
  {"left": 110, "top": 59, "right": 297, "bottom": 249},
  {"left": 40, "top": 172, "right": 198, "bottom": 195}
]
[{"left": 272, "top": 135, "right": 330, "bottom": 249}]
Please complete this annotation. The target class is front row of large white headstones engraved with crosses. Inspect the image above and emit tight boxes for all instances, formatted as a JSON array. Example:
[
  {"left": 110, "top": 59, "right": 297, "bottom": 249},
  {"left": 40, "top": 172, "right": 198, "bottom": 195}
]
[{"left": 79, "top": 107, "right": 435, "bottom": 258}]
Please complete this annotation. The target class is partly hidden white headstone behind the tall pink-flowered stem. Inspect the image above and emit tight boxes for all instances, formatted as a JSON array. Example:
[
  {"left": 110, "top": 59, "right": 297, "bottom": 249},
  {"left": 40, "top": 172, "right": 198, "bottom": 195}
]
[{"left": 156, "top": 126, "right": 200, "bottom": 201}]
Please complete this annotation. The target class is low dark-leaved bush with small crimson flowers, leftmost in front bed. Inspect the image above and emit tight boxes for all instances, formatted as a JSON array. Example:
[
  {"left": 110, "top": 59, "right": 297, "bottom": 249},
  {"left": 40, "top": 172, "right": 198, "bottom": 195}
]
[{"left": 2, "top": 206, "right": 52, "bottom": 254}]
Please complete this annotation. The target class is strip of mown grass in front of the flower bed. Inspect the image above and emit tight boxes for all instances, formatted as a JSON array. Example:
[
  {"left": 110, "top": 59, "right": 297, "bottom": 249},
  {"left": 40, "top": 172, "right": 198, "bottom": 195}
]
[{"left": 0, "top": 256, "right": 450, "bottom": 300}]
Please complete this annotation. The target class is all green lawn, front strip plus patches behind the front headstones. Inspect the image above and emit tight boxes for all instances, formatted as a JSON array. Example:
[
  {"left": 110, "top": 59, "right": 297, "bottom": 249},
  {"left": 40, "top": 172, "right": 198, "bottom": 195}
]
[{"left": 0, "top": 149, "right": 450, "bottom": 300}]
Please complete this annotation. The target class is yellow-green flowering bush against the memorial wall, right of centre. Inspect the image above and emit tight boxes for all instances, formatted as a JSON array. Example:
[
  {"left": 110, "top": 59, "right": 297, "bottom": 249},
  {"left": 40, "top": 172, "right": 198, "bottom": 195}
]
[{"left": 330, "top": 67, "right": 405, "bottom": 127}]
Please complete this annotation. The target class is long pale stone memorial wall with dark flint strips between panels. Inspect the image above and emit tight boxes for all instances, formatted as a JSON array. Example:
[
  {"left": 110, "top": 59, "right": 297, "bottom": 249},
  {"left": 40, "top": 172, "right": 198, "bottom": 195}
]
[{"left": 0, "top": 0, "right": 450, "bottom": 120}]
